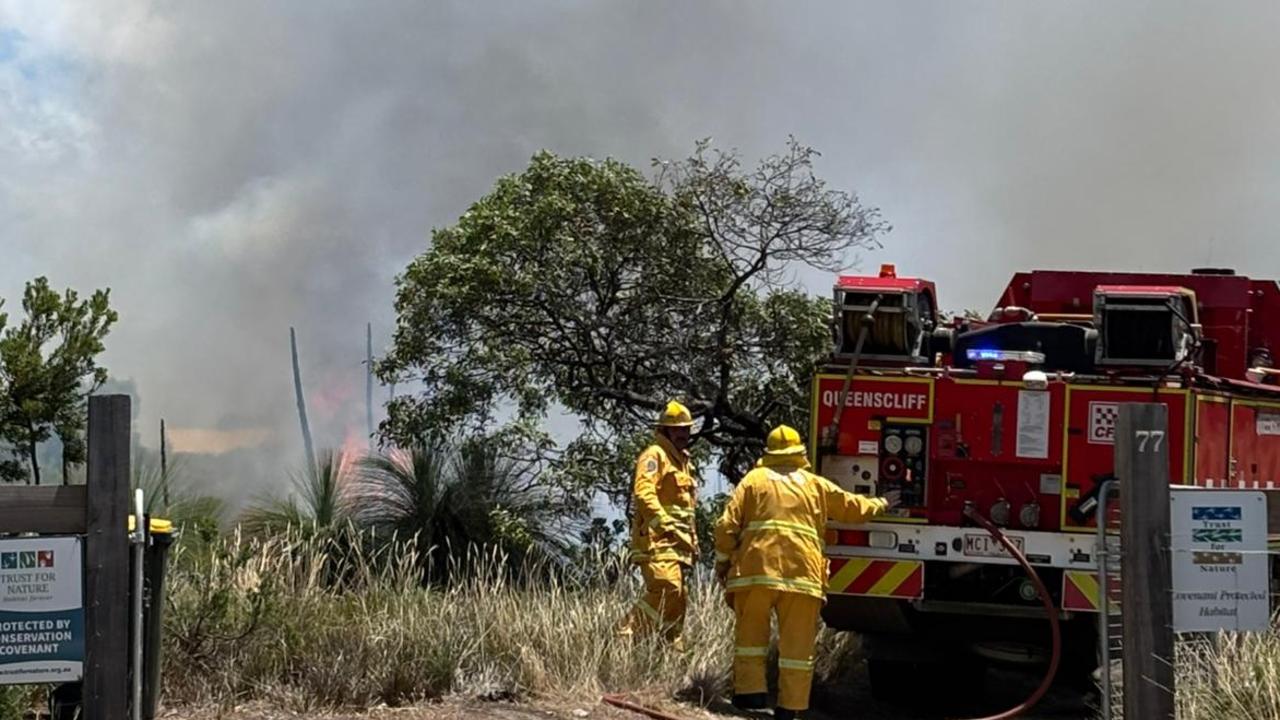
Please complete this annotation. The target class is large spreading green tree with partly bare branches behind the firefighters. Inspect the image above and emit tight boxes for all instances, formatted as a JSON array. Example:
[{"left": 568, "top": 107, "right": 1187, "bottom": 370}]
[{"left": 379, "top": 140, "right": 888, "bottom": 498}]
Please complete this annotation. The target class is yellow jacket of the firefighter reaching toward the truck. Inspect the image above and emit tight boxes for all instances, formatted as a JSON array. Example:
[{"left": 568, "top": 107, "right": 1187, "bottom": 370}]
[{"left": 716, "top": 456, "right": 888, "bottom": 597}]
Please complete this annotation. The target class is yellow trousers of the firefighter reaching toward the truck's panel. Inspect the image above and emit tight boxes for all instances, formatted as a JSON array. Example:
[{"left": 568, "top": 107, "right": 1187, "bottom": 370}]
[{"left": 733, "top": 587, "right": 822, "bottom": 711}]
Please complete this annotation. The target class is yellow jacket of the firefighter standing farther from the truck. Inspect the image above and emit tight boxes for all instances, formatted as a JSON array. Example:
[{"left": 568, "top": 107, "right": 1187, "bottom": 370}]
[{"left": 631, "top": 434, "right": 698, "bottom": 565}]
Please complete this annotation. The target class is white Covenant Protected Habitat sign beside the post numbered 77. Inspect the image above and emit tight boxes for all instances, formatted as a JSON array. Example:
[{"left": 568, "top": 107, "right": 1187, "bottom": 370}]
[{"left": 1171, "top": 488, "right": 1271, "bottom": 633}]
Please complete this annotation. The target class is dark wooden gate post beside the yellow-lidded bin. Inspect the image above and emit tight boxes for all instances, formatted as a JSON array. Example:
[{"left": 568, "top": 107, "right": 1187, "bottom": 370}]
[{"left": 84, "top": 395, "right": 131, "bottom": 720}]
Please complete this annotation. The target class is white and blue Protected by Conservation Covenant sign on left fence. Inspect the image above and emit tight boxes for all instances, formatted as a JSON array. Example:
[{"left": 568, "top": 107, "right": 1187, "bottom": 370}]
[{"left": 0, "top": 537, "right": 84, "bottom": 685}]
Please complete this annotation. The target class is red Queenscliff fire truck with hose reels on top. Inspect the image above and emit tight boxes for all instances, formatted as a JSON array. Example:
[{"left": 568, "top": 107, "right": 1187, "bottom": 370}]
[{"left": 810, "top": 265, "right": 1280, "bottom": 697}]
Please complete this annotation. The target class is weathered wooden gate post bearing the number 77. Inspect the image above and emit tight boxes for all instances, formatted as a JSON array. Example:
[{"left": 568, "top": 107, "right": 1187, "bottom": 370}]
[{"left": 1103, "top": 402, "right": 1174, "bottom": 720}]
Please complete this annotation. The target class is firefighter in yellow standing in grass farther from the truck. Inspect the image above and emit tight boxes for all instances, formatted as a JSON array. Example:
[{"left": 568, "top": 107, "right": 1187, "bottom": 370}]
[{"left": 620, "top": 400, "right": 698, "bottom": 650}]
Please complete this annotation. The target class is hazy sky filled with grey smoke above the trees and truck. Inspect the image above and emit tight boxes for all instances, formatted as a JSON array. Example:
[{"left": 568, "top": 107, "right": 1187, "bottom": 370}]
[{"left": 0, "top": 0, "right": 1280, "bottom": 504}]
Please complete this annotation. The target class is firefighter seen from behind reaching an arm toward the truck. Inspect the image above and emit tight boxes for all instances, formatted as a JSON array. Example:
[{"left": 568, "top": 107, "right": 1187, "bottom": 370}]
[{"left": 716, "top": 425, "right": 900, "bottom": 720}]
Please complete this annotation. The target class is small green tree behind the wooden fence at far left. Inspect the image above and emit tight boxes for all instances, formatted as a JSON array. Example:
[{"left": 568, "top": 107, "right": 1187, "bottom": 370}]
[{"left": 0, "top": 277, "right": 118, "bottom": 484}]
